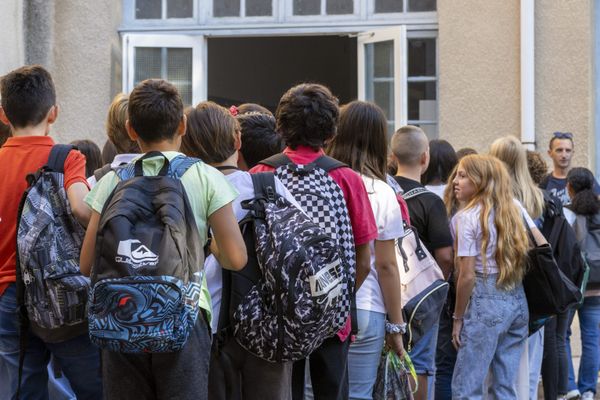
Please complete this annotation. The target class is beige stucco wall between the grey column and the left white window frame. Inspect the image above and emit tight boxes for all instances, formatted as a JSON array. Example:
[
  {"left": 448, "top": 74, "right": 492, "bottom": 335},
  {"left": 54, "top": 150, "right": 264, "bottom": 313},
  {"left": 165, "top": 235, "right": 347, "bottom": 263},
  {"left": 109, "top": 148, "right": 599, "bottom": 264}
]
[{"left": 50, "top": 0, "right": 121, "bottom": 145}]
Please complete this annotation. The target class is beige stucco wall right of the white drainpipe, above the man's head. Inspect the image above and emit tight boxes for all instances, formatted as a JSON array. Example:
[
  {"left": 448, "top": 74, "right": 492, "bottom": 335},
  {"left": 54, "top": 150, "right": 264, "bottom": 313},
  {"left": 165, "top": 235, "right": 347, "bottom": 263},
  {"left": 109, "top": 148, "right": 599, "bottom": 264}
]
[{"left": 535, "top": 0, "right": 595, "bottom": 169}]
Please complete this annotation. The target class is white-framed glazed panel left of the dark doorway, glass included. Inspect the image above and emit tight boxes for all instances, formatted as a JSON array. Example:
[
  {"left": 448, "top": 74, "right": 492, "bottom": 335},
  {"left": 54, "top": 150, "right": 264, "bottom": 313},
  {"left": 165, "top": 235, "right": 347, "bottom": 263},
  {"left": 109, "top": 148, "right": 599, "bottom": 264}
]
[{"left": 123, "top": 35, "right": 206, "bottom": 105}]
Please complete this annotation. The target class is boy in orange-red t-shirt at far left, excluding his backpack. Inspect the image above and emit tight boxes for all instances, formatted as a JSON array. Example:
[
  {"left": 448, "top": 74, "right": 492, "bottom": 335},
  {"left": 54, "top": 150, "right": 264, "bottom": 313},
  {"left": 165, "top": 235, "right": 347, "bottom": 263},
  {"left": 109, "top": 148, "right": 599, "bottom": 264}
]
[{"left": 0, "top": 65, "right": 102, "bottom": 399}]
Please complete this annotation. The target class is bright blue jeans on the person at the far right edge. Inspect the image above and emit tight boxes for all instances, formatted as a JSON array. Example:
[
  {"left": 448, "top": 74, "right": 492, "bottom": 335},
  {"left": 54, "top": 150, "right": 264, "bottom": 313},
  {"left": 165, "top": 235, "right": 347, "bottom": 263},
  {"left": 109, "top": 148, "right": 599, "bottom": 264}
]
[{"left": 567, "top": 296, "right": 600, "bottom": 394}]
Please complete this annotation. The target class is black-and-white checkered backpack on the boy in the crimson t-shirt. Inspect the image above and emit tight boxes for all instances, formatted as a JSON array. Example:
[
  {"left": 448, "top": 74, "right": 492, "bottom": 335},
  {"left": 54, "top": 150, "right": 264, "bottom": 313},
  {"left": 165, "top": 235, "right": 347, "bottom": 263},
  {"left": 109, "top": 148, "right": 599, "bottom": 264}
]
[{"left": 260, "top": 154, "right": 356, "bottom": 331}]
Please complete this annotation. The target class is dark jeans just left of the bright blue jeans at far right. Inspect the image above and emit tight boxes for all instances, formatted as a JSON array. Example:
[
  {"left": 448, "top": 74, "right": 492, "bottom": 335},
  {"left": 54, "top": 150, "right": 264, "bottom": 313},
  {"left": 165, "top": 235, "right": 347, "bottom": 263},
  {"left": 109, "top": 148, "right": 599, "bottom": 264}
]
[{"left": 542, "top": 310, "right": 572, "bottom": 400}]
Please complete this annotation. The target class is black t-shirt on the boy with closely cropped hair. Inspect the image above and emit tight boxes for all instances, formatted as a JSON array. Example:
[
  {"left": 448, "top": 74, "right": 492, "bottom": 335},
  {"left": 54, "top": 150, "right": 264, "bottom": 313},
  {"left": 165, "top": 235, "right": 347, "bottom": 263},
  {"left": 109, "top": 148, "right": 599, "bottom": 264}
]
[{"left": 394, "top": 176, "right": 453, "bottom": 255}]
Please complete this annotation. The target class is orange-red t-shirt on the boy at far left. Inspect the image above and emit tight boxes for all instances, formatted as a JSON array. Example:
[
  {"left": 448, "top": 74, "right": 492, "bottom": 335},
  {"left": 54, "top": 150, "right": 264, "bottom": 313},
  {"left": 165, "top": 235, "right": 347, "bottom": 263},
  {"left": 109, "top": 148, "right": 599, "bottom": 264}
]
[{"left": 0, "top": 136, "right": 87, "bottom": 296}]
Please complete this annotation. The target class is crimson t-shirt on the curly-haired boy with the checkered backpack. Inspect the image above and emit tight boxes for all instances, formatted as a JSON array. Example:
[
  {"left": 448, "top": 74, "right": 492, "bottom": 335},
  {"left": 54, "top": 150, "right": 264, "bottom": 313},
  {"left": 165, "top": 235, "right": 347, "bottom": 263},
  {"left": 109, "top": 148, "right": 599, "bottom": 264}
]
[{"left": 250, "top": 146, "right": 377, "bottom": 246}]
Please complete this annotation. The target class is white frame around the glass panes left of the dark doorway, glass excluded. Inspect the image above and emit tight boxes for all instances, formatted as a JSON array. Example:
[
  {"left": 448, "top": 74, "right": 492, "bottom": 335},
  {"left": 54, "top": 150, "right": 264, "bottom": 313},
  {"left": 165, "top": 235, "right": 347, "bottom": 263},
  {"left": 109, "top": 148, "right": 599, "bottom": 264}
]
[{"left": 123, "top": 34, "right": 208, "bottom": 105}]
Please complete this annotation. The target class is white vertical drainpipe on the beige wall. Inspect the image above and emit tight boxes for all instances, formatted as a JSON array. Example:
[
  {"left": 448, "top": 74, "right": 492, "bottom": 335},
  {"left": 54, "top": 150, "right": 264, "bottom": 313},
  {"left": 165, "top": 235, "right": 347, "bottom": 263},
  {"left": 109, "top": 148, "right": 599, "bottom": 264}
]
[{"left": 521, "top": 0, "right": 535, "bottom": 150}]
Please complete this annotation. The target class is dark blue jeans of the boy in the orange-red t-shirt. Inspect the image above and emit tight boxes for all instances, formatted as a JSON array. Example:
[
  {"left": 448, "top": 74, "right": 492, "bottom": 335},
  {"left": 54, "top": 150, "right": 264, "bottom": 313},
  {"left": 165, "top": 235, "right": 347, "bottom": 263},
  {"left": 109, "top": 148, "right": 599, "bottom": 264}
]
[{"left": 0, "top": 284, "right": 102, "bottom": 400}]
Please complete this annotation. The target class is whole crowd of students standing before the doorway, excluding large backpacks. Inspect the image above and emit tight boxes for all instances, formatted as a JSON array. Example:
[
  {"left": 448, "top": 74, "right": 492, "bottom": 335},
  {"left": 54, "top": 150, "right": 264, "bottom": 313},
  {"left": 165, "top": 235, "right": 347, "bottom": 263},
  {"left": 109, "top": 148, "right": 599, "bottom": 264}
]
[{"left": 0, "top": 66, "right": 600, "bottom": 400}]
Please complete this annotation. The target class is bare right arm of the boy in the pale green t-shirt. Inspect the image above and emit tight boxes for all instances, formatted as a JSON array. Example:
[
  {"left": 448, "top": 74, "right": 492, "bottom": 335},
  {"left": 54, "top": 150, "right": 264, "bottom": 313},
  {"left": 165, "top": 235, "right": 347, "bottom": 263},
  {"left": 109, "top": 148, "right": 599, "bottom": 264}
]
[{"left": 207, "top": 203, "right": 248, "bottom": 271}]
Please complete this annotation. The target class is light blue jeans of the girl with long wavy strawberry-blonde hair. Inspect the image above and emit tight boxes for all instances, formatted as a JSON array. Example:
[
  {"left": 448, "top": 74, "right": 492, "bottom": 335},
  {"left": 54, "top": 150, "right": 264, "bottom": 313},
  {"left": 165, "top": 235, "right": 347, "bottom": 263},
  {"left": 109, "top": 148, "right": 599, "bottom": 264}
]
[{"left": 452, "top": 274, "right": 529, "bottom": 400}]
